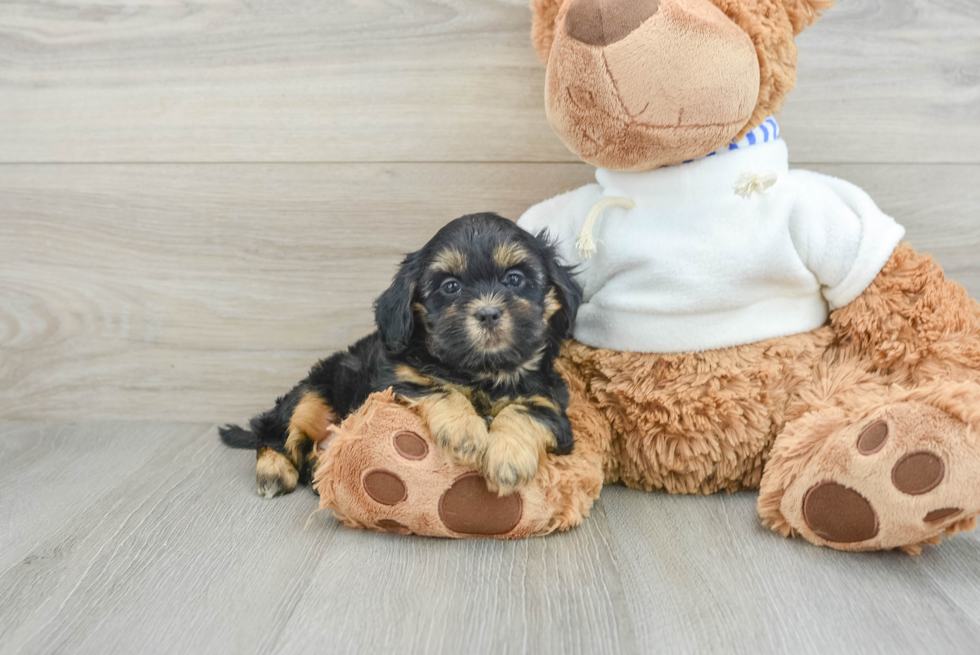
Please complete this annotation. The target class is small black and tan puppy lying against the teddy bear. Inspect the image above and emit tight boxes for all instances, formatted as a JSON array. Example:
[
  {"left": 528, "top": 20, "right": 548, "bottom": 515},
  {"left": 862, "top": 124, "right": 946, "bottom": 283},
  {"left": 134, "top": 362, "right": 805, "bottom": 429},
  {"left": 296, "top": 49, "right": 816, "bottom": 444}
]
[{"left": 221, "top": 214, "right": 582, "bottom": 498}]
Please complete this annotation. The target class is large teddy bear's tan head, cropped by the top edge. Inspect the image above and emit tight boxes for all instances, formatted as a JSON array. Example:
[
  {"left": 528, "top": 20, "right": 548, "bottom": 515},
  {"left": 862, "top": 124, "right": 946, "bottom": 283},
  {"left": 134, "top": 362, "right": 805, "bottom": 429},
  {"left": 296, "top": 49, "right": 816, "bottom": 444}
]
[{"left": 532, "top": 0, "right": 835, "bottom": 171}]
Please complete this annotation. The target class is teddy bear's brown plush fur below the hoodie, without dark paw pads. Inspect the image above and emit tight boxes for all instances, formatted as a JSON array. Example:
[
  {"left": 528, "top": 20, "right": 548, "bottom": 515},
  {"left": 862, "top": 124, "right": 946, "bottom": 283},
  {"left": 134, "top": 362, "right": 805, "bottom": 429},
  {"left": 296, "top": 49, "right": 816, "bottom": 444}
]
[{"left": 317, "top": 244, "right": 980, "bottom": 554}]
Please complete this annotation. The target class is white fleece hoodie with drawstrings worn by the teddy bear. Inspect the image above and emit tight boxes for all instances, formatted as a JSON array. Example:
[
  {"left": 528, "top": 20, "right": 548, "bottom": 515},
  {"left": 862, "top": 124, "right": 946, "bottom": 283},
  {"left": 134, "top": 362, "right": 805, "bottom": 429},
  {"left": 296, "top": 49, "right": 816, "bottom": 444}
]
[{"left": 518, "top": 125, "right": 905, "bottom": 353}]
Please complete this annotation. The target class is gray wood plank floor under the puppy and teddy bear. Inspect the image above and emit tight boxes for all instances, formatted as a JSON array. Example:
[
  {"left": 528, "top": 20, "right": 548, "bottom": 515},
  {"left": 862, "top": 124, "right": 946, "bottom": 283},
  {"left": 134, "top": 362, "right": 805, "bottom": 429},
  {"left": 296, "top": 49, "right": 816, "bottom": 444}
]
[{"left": 0, "top": 422, "right": 980, "bottom": 655}]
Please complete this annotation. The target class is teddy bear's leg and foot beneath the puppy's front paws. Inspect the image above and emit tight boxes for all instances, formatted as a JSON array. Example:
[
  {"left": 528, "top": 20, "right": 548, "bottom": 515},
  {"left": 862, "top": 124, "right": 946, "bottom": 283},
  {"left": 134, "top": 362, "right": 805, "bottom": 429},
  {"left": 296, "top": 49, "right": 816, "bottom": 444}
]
[{"left": 314, "top": 360, "right": 609, "bottom": 539}]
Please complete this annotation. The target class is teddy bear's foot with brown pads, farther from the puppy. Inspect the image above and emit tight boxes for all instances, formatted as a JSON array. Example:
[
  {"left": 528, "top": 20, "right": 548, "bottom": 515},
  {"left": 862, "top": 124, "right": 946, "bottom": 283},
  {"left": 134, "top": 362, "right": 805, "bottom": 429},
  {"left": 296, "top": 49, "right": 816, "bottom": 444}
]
[{"left": 759, "top": 394, "right": 980, "bottom": 553}]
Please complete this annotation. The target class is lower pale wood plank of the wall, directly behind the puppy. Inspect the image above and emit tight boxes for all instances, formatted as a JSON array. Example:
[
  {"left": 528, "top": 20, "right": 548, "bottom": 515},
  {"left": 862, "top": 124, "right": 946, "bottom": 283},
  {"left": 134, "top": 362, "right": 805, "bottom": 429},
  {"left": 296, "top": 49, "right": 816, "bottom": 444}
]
[{"left": 0, "top": 164, "right": 980, "bottom": 421}]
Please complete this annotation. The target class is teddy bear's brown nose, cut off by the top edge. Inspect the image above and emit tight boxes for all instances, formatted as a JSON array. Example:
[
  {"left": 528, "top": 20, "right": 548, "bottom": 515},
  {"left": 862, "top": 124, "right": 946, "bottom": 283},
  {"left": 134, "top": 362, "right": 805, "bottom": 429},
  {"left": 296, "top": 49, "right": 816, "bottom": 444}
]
[{"left": 565, "top": 0, "right": 660, "bottom": 46}]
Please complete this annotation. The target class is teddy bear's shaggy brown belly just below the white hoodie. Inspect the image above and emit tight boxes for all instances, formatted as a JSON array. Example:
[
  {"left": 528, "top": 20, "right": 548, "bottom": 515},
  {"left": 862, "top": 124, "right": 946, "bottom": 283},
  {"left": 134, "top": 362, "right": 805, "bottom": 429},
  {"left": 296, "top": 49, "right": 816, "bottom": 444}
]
[{"left": 563, "top": 328, "right": 833, "bottom": 494}]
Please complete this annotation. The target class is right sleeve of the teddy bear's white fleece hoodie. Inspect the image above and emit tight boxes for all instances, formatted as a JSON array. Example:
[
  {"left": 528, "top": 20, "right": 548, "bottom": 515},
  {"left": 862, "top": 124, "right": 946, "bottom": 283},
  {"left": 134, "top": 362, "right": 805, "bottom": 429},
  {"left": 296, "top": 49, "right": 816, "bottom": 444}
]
[{"left": 790, "top": 170, "right": 905, "bottom": 310}]
